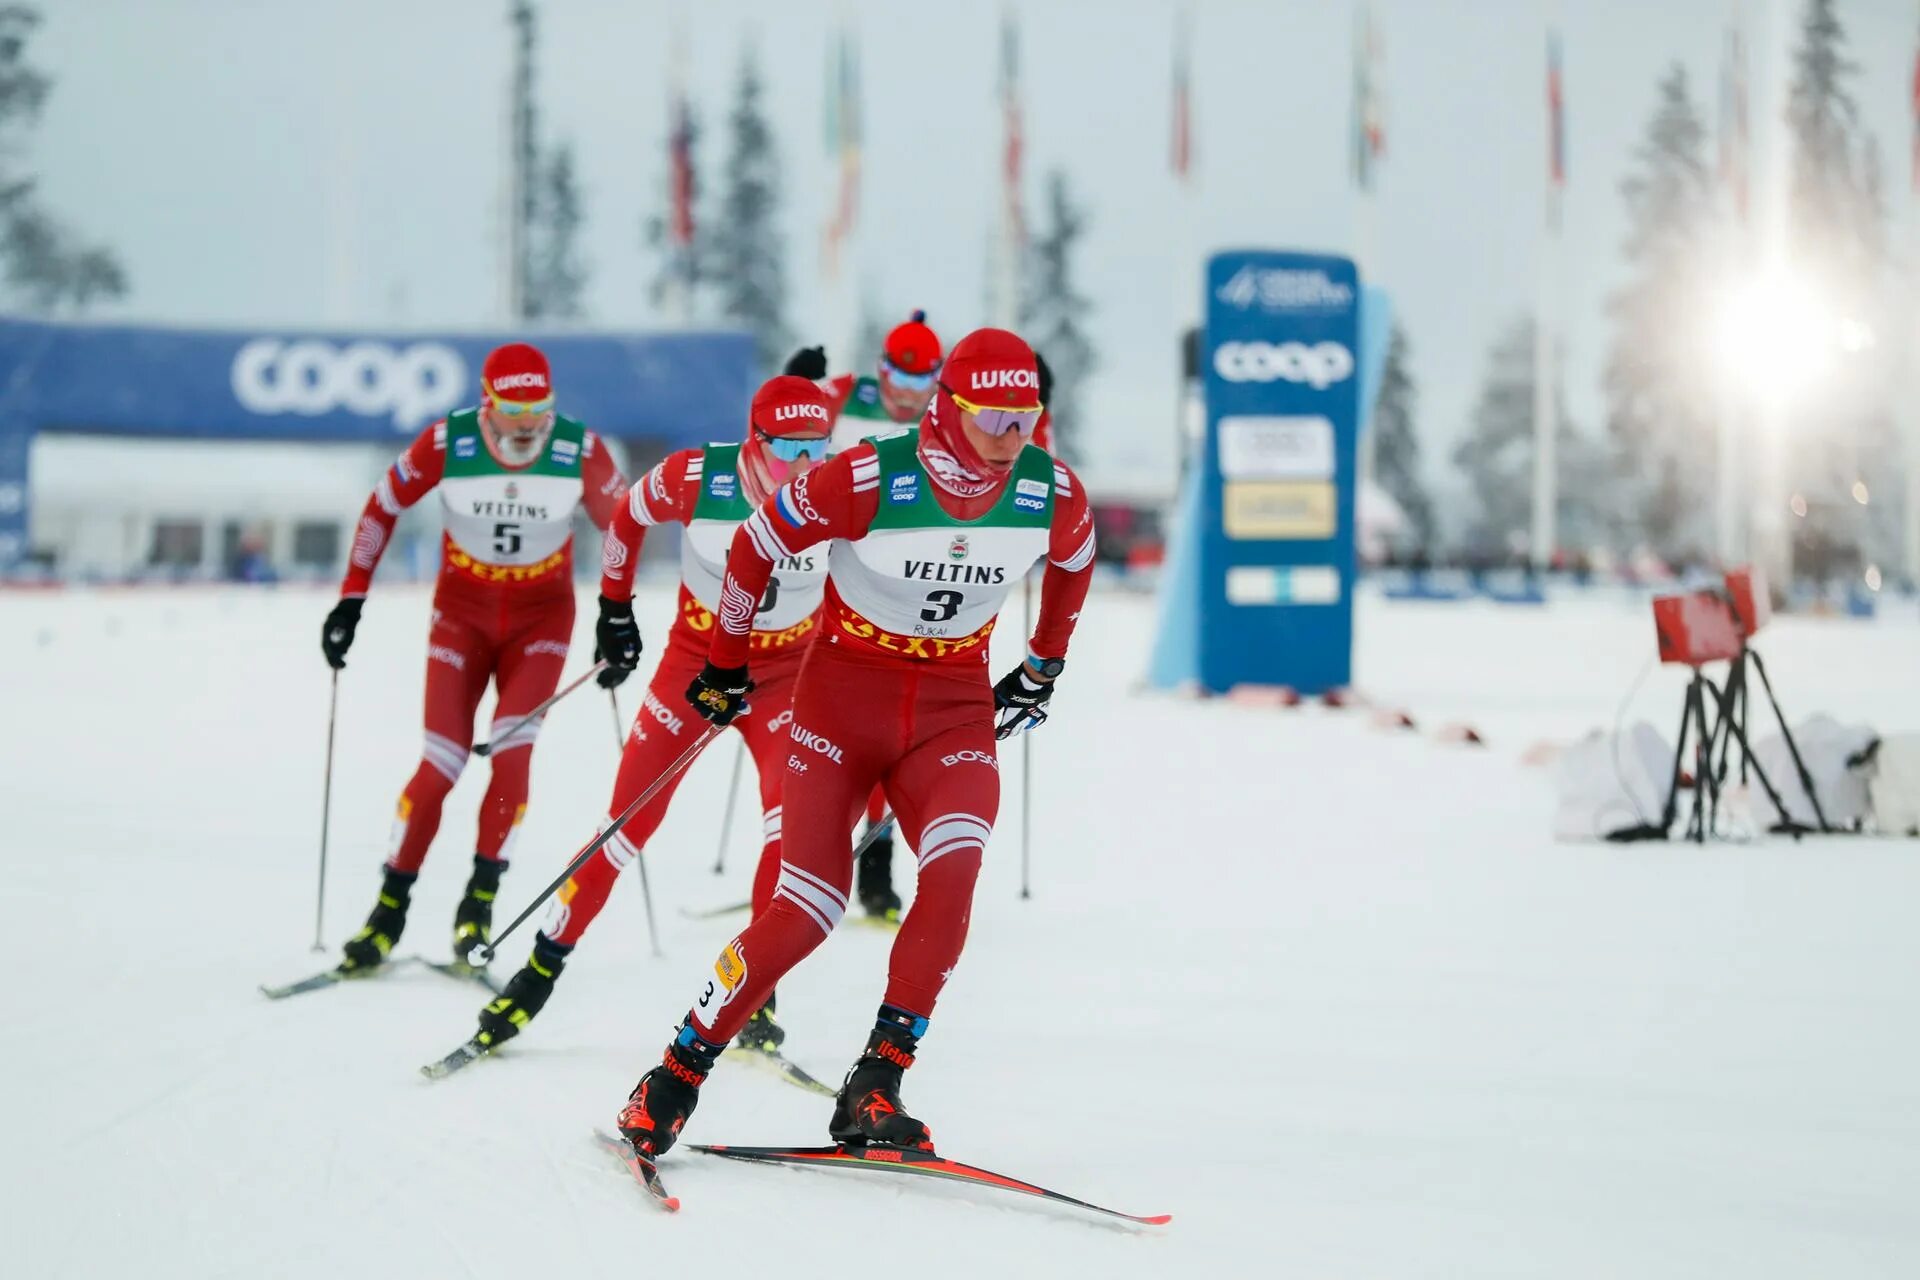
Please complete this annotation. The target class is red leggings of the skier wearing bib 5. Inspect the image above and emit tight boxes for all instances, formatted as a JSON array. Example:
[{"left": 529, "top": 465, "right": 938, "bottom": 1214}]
[{"left": 386, "top": 587, "right": 574, "bottom": 871}]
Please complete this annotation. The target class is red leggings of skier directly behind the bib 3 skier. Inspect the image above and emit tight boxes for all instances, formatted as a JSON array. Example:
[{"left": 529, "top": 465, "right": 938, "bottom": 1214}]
[{"left": 541, "top": 647, "right": 801, "bottom": 946}]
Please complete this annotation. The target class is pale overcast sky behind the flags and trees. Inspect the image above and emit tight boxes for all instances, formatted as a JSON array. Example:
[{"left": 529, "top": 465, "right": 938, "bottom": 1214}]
[{"left": 35, "top": 0, "right": 1920, "bottom": 495}]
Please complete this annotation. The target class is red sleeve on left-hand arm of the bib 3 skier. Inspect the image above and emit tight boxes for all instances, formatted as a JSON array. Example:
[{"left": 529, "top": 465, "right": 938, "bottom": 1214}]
[{"left": 707, "top": 443, "right": 879, "bottom": 668}]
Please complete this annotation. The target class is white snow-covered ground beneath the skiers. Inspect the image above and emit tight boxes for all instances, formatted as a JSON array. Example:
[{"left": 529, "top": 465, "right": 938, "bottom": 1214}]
[{"left": 0, "top": 589, "right": 1920, "bottom": 1280}]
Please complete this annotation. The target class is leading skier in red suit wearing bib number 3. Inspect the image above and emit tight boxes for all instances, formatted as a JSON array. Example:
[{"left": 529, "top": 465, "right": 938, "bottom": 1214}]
[{"left": 618, "top": 328, "right": 1094, "bottom": 1161}]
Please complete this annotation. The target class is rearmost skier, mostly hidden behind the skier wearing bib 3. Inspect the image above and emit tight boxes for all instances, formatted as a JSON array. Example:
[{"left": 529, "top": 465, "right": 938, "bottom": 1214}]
[{"left": 787, "top": 311, "right": 941, "bottom": 919}]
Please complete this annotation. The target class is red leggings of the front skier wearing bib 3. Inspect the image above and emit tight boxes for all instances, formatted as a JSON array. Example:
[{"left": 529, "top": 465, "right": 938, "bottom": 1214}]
[{"left": 691, "top": 635, "right": 1000, "bottom": 1044}]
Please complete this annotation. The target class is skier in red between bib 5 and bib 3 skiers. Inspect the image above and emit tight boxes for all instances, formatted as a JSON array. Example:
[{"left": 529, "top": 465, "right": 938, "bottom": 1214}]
[{"left": 460, "top": 376, "right": 831, "bottom": 1050}]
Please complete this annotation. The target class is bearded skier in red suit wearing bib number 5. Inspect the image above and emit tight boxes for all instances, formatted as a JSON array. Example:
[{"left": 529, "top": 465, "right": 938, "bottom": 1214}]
[{"left": 321, "top": 342, "right": 626, "bottom": 971}]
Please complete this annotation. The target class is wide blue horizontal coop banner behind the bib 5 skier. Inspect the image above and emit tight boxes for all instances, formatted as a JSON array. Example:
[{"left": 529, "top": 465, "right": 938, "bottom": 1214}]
[{"left": 0, "top": 320, "right": 755, "bottom": 570}]
